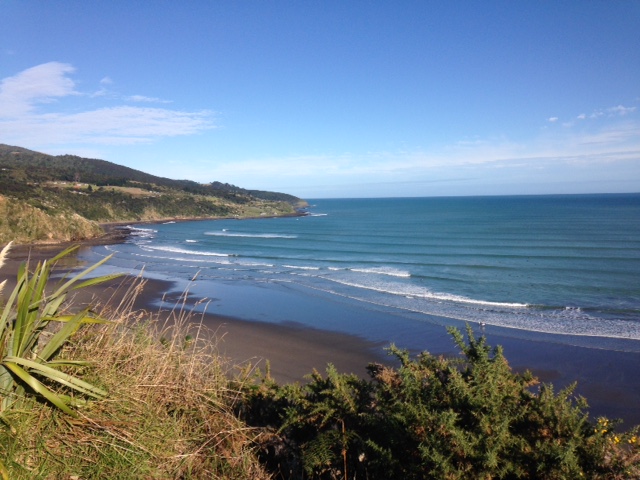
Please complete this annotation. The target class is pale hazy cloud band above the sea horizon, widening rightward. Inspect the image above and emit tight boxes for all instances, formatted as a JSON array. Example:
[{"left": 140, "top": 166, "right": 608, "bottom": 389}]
[{"left": 156, "top": 96, "right": 640, "bottom": 198}]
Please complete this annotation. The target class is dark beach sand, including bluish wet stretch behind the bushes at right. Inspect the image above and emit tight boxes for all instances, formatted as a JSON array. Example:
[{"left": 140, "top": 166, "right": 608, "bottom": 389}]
[{"left": 0, "top": 238, "right": 640, "bottom": 429}]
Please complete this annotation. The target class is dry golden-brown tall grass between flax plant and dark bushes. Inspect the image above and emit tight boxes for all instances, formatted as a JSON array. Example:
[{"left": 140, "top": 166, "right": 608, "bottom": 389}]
[{"left": 0, "top": 246, "right": 267, "bottom": 479}]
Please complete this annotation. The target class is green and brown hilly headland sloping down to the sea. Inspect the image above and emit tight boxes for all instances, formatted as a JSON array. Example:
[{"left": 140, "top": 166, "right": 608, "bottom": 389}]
[{"left": 0, "top": 145, "right": 306, "bottom": 243}]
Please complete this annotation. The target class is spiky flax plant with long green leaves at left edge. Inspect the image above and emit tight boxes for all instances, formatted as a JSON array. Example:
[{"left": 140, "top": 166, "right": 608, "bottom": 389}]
[{"left": 0, "top": 244, "right": 119, "bottom": 424}]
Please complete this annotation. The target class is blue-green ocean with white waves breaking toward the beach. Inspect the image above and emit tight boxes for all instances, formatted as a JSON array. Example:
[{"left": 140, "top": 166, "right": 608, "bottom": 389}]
[{"left": 81, "top": 194, "right": 640, "bottom": 352}]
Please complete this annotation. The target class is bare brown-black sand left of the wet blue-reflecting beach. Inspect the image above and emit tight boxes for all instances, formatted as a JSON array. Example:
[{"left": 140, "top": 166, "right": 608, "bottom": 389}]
[{"left": 0, "top": 237, "right": 388, "bottom": 383}]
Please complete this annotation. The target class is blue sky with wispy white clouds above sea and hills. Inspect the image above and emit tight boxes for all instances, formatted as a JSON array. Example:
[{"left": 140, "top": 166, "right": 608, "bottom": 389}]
[{"left": 0, "top": 0, "right": 640, "bottom": 198}]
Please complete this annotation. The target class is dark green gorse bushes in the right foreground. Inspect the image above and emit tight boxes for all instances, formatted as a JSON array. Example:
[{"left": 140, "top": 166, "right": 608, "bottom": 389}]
[{"left": 239, "top": 328, "right": 640, "bottom": 479}]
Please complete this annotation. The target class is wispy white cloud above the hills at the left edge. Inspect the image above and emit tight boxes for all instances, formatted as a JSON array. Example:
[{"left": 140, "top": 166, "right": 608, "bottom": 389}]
[{"left": 0, "top": 62, "right": 214, "bottom": 148}]
